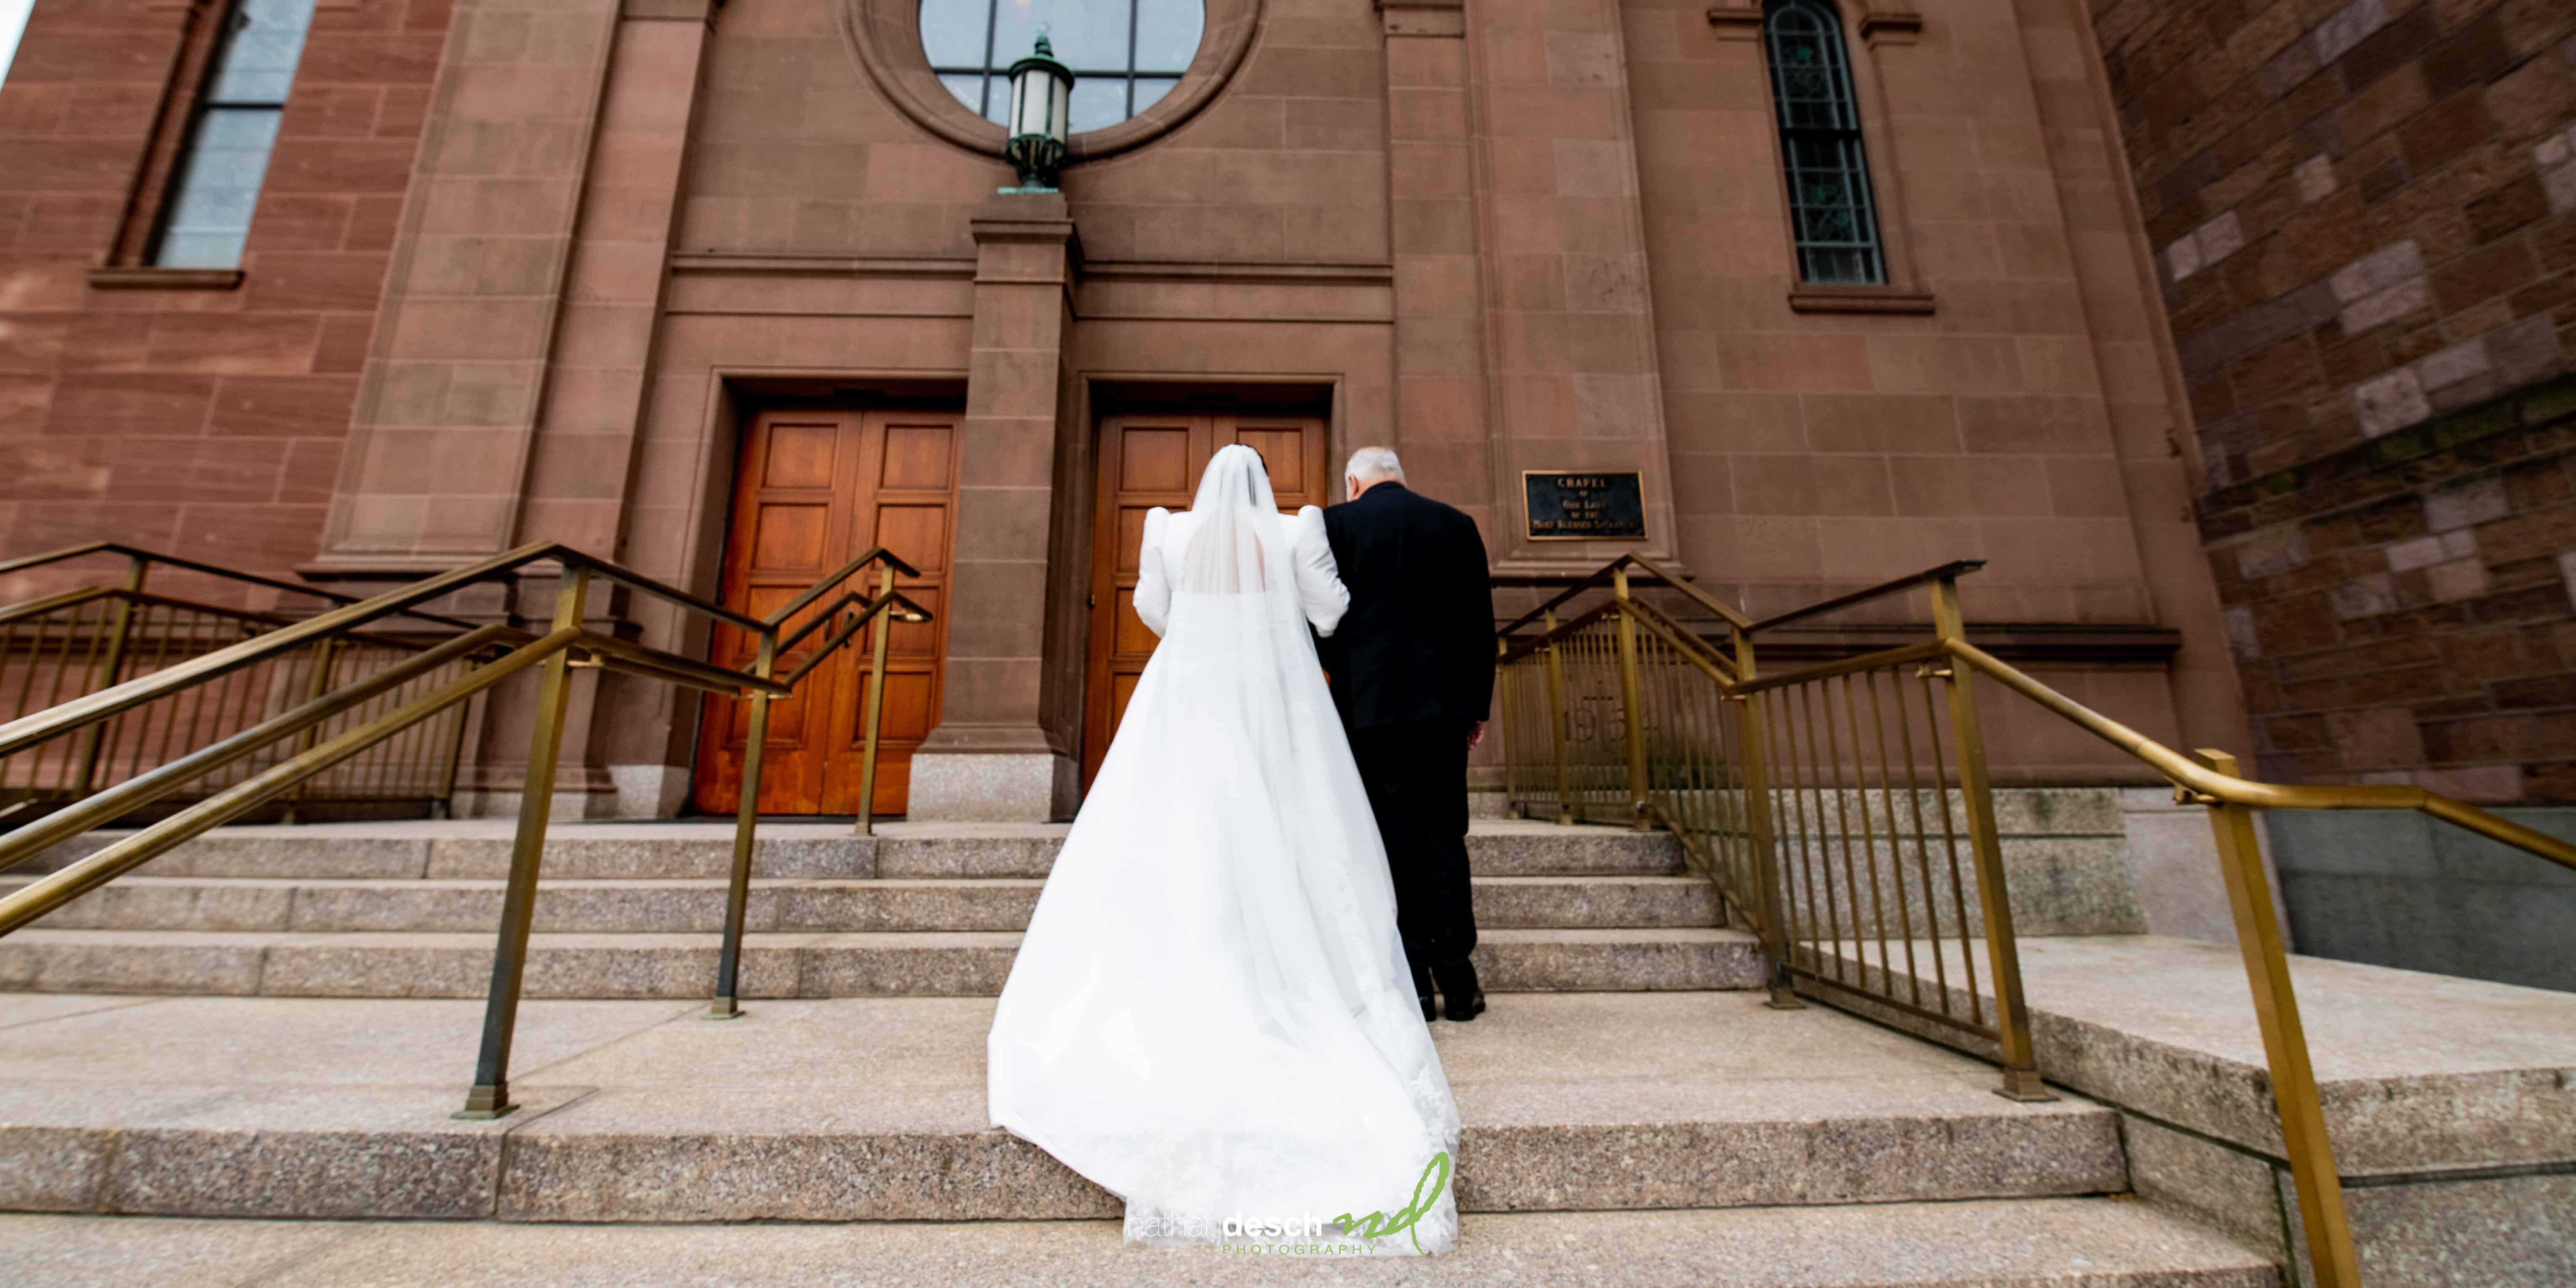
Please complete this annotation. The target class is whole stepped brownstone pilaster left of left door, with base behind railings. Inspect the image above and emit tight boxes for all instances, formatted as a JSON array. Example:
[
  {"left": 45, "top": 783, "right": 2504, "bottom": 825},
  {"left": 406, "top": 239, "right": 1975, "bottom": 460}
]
[{"left": 304, "top": 0, "right": 714, "bottom": 817}]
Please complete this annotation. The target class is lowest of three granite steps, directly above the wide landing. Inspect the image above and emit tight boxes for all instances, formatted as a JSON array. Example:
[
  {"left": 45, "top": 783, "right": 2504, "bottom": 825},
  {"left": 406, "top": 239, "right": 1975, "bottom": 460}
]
[{"left": 0, "top": 927, "right": 1762, "bottom": 1000}]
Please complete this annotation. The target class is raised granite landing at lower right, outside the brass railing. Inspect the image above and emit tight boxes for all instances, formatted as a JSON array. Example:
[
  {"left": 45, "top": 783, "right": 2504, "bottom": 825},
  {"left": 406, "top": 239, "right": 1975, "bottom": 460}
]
[{"left": 1793, "top": 935, "right": 2576, "bottom": 1288}]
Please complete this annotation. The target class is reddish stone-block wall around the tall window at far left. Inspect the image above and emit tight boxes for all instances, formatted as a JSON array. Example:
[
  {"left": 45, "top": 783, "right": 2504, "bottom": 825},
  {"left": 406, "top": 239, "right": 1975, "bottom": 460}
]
[{"left": 0, "top": 0, "right": 448, "bottom": 598}]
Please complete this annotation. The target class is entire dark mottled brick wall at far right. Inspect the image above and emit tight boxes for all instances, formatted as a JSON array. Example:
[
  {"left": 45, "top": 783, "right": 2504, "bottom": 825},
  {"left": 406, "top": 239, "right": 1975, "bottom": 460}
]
[{"left": 2092, "top": 0, "right": 2576, "bottom": 801}]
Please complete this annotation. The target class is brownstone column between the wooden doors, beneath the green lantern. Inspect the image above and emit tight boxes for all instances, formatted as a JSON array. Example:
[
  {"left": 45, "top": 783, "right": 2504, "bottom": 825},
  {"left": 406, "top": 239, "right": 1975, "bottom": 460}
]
[{"left": 909, "top": 193, "right": 1090, "bottom": 822}]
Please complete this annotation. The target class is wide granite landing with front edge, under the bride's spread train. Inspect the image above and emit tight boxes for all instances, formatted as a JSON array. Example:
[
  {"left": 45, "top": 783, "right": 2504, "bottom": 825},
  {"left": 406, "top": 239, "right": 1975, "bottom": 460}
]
[{"left": 0, "top": 992, "right": 2128, "bottom": 1221}]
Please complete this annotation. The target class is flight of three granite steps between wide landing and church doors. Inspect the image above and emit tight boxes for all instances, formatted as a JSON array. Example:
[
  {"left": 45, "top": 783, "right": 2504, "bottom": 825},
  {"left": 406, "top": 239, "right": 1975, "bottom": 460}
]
[{"left": 0, "top": 819, "right": 1759, "bottom": 997}]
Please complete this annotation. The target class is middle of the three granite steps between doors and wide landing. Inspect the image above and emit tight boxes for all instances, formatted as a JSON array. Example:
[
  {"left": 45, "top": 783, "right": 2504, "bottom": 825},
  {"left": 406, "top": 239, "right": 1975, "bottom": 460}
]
[{"left": 0, "top": 876, "right": 1721, "bottom": 935}]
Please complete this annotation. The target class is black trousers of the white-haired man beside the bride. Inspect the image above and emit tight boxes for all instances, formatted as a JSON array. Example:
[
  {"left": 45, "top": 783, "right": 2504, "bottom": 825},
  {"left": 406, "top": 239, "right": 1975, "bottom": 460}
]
[{"left": 1350, "top": 719, "right": 1476, "bottom": 968}]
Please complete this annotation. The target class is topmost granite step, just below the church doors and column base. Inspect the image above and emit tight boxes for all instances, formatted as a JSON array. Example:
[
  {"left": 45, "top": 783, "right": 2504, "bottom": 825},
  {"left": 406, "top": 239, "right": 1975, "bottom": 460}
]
[{"left": 18, "top": 819, "right": 1682, "bottom": 881}]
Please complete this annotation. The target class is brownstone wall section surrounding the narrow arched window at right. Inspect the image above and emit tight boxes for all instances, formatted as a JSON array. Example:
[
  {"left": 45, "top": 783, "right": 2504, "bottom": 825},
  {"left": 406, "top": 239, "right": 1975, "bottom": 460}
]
[{"left": 1628, "top": 0, "right": 2249, "bottom": 775}]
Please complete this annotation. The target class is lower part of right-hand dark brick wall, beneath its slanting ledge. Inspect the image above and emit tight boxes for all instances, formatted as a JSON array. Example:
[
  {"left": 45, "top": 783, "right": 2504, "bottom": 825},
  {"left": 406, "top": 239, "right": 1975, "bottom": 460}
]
[{"left": 2203, "top": 376, "right": 2576, "bottom": 801}]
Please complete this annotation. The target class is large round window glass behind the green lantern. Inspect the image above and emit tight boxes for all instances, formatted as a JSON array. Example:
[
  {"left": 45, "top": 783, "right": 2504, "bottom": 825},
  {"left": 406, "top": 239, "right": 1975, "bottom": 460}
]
[{"left": 922, "top": 0, "right": 1206, "bottom": 134}]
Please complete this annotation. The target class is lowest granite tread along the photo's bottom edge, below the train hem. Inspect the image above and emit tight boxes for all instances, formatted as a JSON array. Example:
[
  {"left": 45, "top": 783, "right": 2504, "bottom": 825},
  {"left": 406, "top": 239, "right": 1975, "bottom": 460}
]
[{"left": 0, "top": 1201, "right": 2280, "bottom": 1288}]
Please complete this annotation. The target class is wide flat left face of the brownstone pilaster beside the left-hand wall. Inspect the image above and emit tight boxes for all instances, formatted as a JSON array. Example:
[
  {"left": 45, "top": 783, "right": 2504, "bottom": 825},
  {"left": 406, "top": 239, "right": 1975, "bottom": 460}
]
[{"left": 314, "top": 0, "right": 618, "bottom": 574}]
